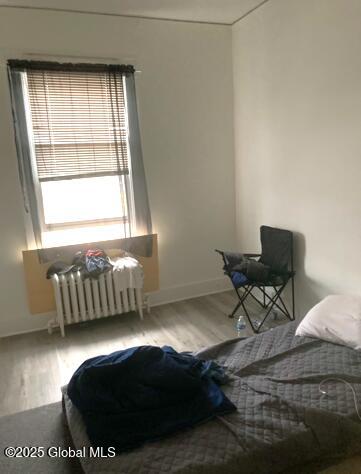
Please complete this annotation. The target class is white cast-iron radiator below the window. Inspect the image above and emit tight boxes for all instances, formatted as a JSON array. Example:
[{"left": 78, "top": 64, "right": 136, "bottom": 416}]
[{"left": 48, "top": 259, "right": 144, "bottom": 336}]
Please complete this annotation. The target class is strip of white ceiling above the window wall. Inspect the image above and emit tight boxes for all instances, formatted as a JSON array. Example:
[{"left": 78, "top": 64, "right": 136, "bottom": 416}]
[{"left": 0, "top": 0, "right": 268, "bottom": 25}]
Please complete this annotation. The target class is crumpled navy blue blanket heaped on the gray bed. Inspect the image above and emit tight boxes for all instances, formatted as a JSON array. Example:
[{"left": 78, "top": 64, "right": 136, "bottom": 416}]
[{"left": 68, "top": 346, "right": 236, "bottom": 453}]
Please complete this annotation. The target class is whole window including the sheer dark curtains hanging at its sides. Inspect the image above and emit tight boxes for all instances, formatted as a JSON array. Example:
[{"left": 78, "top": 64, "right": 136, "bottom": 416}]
[{"left": 9, "top": 61, "right": 150, "bottom": 247}]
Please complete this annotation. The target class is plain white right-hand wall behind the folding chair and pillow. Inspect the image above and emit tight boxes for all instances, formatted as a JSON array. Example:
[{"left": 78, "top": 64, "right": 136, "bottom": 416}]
[{"left": 233, "top": 0, "right": 361, "bottom": 315}]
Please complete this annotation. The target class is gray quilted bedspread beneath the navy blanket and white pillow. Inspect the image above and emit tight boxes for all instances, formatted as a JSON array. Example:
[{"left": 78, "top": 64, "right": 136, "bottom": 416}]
[{"left": 64, "top": 323, "right": 361, "bottom": 474}]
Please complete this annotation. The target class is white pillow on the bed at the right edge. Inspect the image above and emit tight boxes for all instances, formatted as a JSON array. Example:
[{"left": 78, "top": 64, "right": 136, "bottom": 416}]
[{"left": 296, "top": 295, "right": 361, "bottom": 350}]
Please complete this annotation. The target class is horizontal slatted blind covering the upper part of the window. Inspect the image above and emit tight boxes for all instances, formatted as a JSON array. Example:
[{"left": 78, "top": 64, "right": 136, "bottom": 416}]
[{"left": 26, "top": 69, "right": 129, "bottom": 181}]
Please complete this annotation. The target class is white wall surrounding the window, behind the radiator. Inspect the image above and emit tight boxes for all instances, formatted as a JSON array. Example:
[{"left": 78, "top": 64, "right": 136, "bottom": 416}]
[{"left": 0, "top": 8, "right": 235, "bottom": 335}]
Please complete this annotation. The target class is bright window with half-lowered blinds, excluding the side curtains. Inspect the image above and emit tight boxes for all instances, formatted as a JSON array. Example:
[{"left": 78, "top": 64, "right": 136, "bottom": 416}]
[{"left": 22, "top": 65, "right": 132, "bottom": 247}]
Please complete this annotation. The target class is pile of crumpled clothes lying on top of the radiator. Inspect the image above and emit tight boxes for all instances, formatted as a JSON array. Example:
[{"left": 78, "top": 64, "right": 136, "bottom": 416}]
[{"left": 46, "top": 249, "right": 140, "bottom": 287}]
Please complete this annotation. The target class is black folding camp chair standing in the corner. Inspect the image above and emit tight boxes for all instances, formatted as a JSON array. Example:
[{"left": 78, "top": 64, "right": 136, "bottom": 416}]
[{"left": 216, "top": 226, "right": 295, "bottom": 333}]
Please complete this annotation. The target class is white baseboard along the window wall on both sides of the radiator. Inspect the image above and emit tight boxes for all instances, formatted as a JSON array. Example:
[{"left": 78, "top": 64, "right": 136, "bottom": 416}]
[{"left": 0, "top": 277, "right": 232, "bottom": 339}]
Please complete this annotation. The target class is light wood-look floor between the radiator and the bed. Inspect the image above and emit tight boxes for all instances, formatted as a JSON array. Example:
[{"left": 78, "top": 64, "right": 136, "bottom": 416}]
[{"left": 0, "top": 292, "right": 361, "bottom": 474}]
